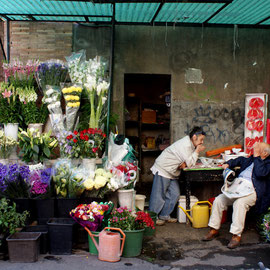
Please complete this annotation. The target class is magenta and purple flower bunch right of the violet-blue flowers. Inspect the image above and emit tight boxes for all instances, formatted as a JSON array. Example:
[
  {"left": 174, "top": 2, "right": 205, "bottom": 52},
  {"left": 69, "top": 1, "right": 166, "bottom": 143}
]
[{"left": 30, "top": 168, "right": 52, "bottom": 197}]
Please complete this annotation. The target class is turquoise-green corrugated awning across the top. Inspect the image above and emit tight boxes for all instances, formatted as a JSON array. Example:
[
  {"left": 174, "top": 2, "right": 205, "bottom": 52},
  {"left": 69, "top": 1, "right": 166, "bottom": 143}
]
[{"left": 0, "top": 0, "right": 270, "bottom": 27}]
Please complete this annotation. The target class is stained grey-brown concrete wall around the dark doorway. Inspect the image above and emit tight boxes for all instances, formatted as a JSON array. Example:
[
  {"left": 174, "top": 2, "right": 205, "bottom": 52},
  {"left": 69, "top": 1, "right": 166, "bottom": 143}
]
[{"left": 114, "top": 26, "right": 270, "bottom": 149}]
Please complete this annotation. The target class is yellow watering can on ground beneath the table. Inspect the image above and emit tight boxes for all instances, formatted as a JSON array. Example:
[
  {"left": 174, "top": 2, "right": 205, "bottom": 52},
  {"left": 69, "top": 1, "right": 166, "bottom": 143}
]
[{"left": 178, "top": 201, "right": 212, "bottom": 228}]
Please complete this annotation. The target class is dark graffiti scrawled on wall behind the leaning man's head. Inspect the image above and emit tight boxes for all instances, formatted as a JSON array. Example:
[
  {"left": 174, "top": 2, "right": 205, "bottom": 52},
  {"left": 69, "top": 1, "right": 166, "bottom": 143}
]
[{"left": 185, "top": 105, "right": 244, "bottom": 145}]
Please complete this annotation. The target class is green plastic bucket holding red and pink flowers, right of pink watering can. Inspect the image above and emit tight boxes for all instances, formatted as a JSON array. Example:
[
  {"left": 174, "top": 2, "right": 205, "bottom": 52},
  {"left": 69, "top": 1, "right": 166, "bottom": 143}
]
[{"left": 122, "top": 229, "right": 144, "bottom": 258}]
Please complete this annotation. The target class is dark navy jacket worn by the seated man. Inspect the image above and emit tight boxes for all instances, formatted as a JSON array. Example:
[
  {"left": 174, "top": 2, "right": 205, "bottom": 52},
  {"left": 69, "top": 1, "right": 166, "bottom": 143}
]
[{"left": 226, "top": 156, "right": 270, "bottom": 214}]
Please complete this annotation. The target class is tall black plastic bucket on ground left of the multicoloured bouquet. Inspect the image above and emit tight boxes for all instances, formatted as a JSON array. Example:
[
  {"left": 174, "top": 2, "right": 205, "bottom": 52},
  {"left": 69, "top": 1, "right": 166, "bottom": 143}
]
[{"left": 47, "top": 218, "right": 75, "bottom": 255}]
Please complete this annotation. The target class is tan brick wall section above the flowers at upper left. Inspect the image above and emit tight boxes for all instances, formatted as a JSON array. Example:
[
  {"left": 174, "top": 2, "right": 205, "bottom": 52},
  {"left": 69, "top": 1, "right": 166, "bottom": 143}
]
[{"left": 10, "top": 22, "right": 72, "bottom": 62}]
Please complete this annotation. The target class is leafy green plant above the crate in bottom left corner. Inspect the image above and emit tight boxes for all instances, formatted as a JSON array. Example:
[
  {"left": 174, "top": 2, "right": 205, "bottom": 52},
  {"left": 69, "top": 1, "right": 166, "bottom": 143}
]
[{"left": 0, "top": 198, "right": 29, "bottom": 234}]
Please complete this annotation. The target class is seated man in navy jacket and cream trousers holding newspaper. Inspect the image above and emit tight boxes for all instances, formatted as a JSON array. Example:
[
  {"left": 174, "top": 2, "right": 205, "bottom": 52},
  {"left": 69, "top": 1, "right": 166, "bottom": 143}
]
[{"left": 203, "top": 143, "right": 270, "bottom": 249}]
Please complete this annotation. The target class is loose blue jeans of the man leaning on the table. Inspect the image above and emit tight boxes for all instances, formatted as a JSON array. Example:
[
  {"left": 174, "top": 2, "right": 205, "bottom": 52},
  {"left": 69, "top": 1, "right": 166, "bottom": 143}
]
[{"left": 149, "top": 173, "right": 180, "bottom": 220}]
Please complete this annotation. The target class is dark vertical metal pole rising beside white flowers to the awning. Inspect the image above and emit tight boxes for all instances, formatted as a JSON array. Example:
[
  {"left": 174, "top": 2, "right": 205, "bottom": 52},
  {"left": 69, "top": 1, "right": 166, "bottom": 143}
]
[{"left": 106, "top": 3, "right": 115, "bottom": 156}]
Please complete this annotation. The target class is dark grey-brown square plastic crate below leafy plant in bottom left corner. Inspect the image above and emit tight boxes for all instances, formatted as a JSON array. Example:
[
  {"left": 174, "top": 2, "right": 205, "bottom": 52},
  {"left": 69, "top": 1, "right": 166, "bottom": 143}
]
[{"left": 7, "top": 232, "right": 41, "bottom": 262}]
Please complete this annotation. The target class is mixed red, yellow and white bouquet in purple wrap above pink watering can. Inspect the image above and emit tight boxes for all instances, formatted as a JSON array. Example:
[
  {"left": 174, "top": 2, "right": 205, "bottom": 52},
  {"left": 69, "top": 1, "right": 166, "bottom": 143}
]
[{"left": 70, "top": 202, "right": 114, "bottom": 231}]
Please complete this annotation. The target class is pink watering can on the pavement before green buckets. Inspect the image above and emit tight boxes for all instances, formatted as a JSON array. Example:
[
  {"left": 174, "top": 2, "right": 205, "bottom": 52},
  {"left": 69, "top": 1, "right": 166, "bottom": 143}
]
[{"left": 85, "top": 227, "right": 126, "bottom": 262}]
